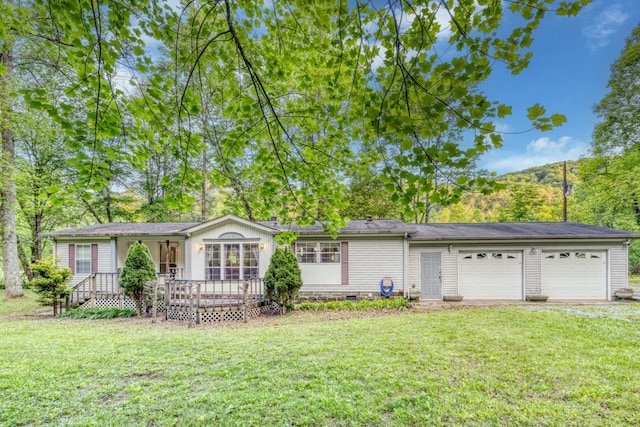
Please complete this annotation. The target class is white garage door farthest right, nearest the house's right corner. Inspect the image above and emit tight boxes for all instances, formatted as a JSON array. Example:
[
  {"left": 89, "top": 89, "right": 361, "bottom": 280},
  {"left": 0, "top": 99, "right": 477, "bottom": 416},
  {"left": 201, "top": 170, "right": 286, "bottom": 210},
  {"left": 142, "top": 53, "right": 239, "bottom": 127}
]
[{"left": 542, "top": 250, "right": 607, "bottom": 299}]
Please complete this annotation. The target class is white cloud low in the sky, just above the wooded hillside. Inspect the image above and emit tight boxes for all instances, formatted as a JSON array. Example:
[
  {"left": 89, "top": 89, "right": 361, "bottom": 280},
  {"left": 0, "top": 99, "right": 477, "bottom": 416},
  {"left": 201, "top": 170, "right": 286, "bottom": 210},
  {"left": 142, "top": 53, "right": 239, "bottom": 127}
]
[{"left": 481, "top": 136, "right": 589, "bottom": 174}]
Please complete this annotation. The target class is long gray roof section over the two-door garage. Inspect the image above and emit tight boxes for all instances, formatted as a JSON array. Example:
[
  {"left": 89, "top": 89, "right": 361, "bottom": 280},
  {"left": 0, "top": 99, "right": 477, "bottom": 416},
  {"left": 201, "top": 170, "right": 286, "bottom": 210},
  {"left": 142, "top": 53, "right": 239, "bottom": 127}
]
[{"left": 411, "top": 222, "right": 640, "bottom": 240}]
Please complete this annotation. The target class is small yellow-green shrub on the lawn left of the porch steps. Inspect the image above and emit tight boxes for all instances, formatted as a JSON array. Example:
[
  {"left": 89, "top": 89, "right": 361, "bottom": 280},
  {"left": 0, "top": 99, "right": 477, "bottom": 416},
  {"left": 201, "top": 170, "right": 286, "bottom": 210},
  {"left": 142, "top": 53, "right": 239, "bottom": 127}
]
[{"left": 31, "top": 257, "right": 72, "bottom": 317}]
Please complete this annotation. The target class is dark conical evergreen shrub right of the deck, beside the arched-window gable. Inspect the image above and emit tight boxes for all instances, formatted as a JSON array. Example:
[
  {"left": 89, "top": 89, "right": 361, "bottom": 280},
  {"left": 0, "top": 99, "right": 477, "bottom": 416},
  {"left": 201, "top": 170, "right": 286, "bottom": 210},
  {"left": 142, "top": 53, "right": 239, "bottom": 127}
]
[{"left": 264, "top": 247, "right": 302, "bottom": 314}]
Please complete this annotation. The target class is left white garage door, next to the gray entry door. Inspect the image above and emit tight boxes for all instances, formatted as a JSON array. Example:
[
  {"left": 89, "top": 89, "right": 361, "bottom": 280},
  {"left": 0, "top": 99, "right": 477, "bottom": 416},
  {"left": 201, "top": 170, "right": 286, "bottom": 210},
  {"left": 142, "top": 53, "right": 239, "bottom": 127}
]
[{"left": 458, "top": 251, "right": 522, "bottom": 299}]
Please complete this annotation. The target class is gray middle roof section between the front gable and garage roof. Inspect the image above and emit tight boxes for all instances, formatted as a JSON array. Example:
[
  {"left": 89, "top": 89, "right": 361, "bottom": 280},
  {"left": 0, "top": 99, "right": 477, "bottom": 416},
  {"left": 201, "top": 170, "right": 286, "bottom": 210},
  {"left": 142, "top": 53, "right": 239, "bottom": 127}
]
[{"left": 258, "top": 219, "right": 416, "bottom": 235}]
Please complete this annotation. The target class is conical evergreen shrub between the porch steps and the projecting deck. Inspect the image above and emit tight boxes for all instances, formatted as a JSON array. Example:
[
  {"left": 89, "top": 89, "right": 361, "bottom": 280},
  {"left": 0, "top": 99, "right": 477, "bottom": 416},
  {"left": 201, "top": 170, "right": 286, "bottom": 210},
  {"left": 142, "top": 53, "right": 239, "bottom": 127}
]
[{"left": 120, "top": 242, "right": 156, "bottom": 317}]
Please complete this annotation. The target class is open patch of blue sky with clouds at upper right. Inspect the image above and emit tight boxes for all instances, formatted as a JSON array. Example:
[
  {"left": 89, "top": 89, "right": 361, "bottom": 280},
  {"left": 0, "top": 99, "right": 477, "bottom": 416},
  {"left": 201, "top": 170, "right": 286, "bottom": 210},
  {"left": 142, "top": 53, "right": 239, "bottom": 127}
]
[{"left": 479, "top": 0, "right": 640, "bottom": 174}]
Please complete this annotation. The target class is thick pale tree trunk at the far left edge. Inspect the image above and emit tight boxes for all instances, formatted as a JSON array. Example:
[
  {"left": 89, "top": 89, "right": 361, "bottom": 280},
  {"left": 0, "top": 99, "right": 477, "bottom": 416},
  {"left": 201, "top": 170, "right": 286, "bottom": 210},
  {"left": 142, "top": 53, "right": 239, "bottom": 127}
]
[{"left": 0, "top": 47, "right": 23, "bottom": 298}]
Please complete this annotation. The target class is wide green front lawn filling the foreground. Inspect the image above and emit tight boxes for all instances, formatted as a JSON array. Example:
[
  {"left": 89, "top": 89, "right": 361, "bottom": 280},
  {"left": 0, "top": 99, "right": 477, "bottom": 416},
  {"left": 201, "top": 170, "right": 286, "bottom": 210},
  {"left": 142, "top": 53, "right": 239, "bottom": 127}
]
[{"left": 0, "top": 307, "right": 640, "bottom": 426}]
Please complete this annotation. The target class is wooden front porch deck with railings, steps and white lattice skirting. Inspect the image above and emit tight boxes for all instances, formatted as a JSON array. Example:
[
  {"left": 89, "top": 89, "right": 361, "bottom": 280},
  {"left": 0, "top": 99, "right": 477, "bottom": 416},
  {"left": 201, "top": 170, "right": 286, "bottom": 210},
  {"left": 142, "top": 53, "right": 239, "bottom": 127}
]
[{"left": 60, "top": 271, "right": 267, "bottom": 325}]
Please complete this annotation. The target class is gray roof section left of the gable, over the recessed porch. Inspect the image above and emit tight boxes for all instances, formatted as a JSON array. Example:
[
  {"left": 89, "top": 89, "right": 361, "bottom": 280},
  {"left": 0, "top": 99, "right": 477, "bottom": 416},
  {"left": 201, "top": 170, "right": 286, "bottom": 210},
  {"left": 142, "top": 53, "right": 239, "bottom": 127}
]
[{"left": 43, "top": 222, "right": 200, "bottom": 237}]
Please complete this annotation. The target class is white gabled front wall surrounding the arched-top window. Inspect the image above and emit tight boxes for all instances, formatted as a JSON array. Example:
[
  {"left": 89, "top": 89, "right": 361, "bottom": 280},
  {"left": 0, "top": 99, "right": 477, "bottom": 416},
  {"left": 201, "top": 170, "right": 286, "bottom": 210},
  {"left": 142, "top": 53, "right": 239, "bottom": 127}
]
[{"left": 186, "top": 221, "right": 276, "bottom": 280}]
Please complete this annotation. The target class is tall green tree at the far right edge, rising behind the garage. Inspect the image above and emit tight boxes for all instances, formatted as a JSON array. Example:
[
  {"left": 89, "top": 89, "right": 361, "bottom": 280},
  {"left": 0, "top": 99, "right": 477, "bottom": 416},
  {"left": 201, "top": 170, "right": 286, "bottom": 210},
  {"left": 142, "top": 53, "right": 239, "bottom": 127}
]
[{"left": 580, "top": 25, "right": 640, "bottom": 230}]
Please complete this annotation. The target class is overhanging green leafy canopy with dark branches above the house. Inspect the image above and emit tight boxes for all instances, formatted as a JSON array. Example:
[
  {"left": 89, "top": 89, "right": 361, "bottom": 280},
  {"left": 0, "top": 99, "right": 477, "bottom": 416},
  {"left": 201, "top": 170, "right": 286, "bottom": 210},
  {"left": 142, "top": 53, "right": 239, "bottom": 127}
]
[{"left": 0, "top": 0, "right": 589, "bottom": 294}]
